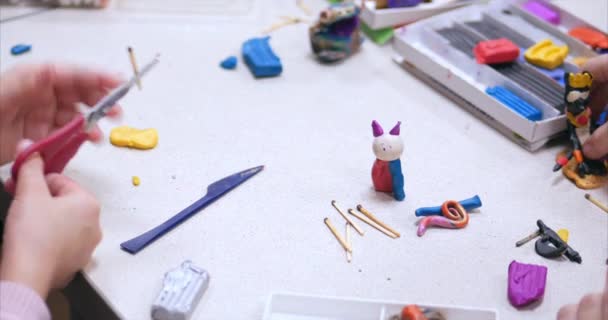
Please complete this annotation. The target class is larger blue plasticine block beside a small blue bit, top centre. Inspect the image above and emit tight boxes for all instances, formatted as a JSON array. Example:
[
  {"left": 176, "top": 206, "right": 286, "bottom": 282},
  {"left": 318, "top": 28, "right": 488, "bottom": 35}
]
[{"left": 242, "top": 37, "right": 283, "bottom": 78}]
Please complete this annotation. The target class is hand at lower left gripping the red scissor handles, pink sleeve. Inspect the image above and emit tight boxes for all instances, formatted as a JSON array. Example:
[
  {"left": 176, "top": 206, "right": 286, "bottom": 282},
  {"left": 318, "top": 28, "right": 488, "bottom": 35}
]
[{"left": 0, "top": 155, "right": 101, "bottom": 298}]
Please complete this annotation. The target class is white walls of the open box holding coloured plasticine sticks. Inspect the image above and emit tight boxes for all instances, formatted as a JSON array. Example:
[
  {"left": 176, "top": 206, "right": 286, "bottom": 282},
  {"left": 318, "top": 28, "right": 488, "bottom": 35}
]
[{"left": 395, "top": 1, "right": 595, "bottom": 151}]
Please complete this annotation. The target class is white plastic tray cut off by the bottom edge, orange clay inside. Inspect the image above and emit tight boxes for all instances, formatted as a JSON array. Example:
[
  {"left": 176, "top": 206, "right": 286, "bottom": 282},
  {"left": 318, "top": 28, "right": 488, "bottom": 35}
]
[{"left": 263, "top": 293, "right": 498, "bottom": 320}]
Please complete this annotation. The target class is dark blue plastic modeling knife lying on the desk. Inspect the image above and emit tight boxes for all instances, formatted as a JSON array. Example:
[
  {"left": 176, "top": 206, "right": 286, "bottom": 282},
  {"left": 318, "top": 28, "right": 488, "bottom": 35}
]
[{"left": 120, "top": 166, "right": 264, "bottom": 254}]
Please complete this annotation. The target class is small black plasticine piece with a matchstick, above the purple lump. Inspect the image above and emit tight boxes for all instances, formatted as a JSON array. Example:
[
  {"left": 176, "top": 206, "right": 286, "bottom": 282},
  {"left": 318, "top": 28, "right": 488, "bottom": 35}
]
[{"left": 515, "top": 220, "right": 583, "bottom": 263}]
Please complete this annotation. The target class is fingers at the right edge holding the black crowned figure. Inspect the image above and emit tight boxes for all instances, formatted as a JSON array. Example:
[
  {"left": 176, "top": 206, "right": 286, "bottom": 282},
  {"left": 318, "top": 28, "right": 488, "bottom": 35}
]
[{"left": 582, "top": 54, "right": 608, "bottom": 159}]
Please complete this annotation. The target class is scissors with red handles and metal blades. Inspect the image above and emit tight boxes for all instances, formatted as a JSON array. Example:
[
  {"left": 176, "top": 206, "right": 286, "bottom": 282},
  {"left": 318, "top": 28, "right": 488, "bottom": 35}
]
[{"left": 6, "top": 57, "right": 159, "bottom": 193}]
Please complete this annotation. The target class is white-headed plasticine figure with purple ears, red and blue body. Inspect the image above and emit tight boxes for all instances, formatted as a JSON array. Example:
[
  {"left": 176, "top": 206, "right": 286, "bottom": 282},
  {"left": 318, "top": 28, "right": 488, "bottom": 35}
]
[{"left": 372, "top": 120, "right": 405, "bottom": 201}]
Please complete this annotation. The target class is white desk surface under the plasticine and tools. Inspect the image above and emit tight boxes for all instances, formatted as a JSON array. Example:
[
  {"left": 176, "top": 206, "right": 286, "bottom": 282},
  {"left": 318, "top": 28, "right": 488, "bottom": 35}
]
[{"left": 0, "top": 0, "right": 608, "bottom": 319}]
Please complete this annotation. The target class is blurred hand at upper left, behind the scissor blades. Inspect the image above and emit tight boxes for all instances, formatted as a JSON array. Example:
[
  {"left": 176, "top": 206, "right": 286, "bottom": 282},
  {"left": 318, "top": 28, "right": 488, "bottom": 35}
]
[{"left": 0, "top": 64, "right": 121, "bottom": 165}]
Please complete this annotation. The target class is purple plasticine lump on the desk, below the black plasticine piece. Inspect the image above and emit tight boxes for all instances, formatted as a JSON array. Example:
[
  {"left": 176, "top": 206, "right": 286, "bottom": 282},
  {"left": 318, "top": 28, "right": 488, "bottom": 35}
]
[{"left": 508, "top": 260, "right": 547, "bottom": 308}]
